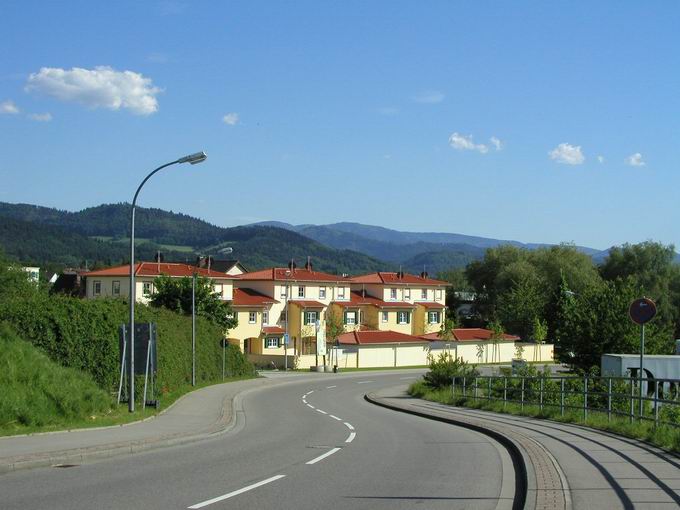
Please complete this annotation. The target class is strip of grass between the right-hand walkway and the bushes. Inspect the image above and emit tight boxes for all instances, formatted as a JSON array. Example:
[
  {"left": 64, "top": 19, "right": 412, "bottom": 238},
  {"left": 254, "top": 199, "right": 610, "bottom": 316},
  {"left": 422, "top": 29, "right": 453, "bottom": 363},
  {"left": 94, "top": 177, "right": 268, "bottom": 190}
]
[{"left": 409, "top": 381, "right": 680, "bottom": 454}]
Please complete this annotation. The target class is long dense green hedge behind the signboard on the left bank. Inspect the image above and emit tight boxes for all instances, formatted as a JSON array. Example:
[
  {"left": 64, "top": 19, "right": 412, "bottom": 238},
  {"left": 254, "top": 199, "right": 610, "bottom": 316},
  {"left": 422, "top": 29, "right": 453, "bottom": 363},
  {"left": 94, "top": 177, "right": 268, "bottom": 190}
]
[{"left": 0, "top": 292, "right": 254, "bottom": 393}]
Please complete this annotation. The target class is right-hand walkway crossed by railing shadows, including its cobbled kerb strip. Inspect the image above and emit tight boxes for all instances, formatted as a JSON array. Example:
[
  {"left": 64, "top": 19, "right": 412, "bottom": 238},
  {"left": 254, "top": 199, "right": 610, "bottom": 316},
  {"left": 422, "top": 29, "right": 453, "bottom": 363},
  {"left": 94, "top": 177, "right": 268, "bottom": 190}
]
[{"left": 368, "top": 386, "right": 680, "bottom": 510}]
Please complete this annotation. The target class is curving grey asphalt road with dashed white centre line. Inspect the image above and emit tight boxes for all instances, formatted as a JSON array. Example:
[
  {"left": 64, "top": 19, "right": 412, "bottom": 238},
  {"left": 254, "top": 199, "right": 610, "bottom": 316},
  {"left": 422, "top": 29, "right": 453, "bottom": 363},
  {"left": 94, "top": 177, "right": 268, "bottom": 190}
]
[{"left": 0, "top": 372, "right": 514, "bottom": 510}]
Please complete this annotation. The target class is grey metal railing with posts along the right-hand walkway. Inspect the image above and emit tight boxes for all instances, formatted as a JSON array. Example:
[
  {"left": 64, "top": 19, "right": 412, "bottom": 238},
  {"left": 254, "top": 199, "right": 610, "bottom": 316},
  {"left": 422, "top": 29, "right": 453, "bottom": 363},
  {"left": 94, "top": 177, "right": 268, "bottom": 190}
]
[{"left": 451, "top": 375, "right": 680, "bottom": 427}]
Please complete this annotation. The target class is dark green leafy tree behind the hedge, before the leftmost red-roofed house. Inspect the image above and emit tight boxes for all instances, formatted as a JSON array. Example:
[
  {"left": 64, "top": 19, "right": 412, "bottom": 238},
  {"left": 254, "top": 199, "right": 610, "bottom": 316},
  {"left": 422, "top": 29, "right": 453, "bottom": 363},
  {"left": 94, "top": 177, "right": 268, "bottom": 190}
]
[{"left": 151, "top": 275, "right": 238, "bottom": 334}]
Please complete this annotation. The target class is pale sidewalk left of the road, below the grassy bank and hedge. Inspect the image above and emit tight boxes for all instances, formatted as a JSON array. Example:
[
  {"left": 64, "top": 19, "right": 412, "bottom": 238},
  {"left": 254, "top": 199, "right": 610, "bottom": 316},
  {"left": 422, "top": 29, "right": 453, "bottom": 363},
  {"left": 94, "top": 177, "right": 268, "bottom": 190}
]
[{"left": 0, "top": 378, "right": 281, "bottom": 474}]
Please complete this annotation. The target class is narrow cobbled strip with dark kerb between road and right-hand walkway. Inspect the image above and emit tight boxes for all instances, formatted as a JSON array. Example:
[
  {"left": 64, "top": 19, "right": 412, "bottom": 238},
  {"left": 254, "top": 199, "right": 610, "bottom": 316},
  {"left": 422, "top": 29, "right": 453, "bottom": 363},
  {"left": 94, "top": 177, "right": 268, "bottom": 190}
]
[{"left": 364, "top": 393, "right": 571, "bottom": 510}]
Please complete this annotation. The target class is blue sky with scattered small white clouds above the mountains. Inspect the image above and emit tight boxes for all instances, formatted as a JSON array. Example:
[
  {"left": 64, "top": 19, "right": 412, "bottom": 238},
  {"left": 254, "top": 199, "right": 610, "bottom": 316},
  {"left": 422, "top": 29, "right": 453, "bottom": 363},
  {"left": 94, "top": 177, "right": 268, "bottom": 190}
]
[{"left": 0, "top": 0, "right": 680, "bottom": 249}]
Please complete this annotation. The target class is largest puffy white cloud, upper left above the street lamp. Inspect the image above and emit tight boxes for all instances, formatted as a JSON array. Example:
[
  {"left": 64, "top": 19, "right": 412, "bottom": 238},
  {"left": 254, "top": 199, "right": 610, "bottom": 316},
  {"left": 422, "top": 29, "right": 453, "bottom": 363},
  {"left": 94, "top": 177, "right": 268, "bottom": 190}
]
[{"left": 26, "top": 66, "right": 161, "bottom": 115}]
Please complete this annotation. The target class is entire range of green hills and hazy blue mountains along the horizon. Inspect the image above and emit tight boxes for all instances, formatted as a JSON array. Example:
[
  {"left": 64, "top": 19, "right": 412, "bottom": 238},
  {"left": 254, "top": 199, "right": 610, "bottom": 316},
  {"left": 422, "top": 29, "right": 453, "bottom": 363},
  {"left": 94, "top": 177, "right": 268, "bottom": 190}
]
[{"left": 0, "top": 202, "right": 652, "bottom": 274}]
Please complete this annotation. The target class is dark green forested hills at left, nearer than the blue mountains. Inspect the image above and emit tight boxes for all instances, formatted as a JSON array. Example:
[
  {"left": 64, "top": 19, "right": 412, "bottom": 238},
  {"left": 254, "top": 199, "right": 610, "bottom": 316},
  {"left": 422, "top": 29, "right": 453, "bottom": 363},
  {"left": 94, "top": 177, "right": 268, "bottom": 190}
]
[{"left": 0, "top": 202, "right": 391, "bottom": 274}]
